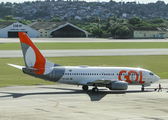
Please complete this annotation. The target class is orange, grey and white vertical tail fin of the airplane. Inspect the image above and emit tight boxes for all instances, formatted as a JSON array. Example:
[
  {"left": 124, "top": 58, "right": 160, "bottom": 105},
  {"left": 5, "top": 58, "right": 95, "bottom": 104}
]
[{"left": 18, "top": 32, "right": 56, "bottom": 75}]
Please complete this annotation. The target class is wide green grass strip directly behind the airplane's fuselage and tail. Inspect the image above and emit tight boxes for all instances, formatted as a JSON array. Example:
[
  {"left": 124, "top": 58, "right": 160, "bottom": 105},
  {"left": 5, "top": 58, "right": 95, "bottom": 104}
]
[{"left": 0, "top": 56, "right": 168, "bottom": 86}]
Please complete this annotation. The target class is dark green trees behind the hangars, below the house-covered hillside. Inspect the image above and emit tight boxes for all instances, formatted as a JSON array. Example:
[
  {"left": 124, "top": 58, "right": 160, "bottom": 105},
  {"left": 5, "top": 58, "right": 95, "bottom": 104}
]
[{"left": 0, "top": 15, "right": 168, "bottom": 38}]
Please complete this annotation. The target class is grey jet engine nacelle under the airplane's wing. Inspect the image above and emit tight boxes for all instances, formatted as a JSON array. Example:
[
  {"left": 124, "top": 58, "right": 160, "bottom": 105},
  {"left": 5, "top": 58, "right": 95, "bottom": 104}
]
[{"left": 107, "top": 81, "right": 128, "bottom": 90}]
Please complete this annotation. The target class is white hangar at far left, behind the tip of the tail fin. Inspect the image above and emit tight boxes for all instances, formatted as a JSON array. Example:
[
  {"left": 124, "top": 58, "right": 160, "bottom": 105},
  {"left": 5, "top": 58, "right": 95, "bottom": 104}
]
[{"left": 0, "top": 21, "right": 39, "bottom": 38}]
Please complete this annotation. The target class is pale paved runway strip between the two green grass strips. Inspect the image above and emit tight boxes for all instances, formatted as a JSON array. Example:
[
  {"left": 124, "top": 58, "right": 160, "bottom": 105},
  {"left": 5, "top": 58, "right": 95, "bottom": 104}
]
[{"left": 0, "top": 49, "right": 168, "bottom": 58}]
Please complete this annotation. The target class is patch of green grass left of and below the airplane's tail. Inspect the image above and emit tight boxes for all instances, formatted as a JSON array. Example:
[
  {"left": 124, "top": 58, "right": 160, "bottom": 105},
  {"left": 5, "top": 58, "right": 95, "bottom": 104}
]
[{"left": 0, "top": 58, "right": 55, "bottom": 86}]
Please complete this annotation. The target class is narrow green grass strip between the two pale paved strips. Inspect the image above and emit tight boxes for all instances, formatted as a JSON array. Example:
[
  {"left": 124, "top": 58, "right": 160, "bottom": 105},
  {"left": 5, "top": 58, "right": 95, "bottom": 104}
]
[{"left": 0, "top": 42, "right": 168, "bottom": 50}]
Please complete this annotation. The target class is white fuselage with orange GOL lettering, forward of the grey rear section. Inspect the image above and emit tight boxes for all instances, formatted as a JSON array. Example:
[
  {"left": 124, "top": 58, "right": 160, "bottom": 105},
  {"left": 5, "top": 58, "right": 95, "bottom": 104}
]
[{"left": 58, "top": 66, "right": 159, "bottom": 85}]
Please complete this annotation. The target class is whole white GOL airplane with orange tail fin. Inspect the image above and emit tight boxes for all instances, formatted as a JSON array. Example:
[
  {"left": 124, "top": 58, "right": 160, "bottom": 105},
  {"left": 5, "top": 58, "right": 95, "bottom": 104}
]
[{"left": 8, "top": 32, "right": 160, "bottom": 92}]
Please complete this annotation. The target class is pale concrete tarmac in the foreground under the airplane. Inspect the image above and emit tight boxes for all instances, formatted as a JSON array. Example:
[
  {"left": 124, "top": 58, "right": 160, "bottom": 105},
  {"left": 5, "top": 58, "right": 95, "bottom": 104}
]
[{"left": 0, "top": 80, "right": 168, "bottom": 120}]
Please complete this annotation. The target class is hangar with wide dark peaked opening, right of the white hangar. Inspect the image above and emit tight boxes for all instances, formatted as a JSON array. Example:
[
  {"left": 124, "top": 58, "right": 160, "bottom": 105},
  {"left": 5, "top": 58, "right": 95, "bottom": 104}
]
[{"left": 28, "top": 22, "right": 88, "bottom": 38}]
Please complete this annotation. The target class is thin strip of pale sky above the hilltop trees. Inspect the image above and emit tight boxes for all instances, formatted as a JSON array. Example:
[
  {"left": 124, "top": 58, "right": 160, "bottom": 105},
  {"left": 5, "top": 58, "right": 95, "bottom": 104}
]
[{"left": 0, "top": 0, "right": 168, "bottom": 4}]
